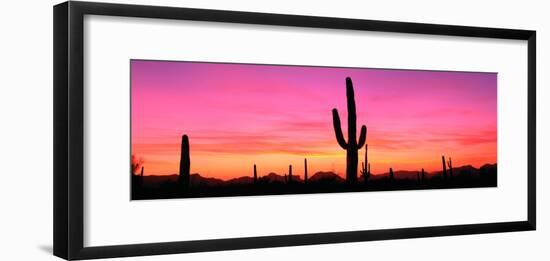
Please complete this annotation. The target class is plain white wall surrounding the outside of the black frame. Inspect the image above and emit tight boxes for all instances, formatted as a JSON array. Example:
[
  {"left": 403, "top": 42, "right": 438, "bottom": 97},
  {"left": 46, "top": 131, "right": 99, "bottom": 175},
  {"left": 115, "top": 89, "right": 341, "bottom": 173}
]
[{"left": 0, "top": 0, "right": 550, "bottom": 260}]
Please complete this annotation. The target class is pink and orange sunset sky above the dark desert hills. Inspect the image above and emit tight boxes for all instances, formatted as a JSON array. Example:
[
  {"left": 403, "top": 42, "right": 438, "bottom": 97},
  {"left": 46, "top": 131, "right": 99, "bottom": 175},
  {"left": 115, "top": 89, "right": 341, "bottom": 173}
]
[{"left": 131, "top": 60, "right": 497, "bottom": 179}]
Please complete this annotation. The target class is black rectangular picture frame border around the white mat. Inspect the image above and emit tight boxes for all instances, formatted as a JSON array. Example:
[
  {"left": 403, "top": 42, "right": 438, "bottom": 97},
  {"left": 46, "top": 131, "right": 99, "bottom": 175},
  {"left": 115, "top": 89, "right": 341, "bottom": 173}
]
[{"left": 53, "top": 1, "right": 536, "bottom": 260}]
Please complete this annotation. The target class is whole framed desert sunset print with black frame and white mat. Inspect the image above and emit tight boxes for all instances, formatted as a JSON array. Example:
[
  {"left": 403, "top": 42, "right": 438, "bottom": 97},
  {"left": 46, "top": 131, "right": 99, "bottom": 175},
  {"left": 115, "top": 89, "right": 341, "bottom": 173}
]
[{"left": 54, "top": 1, "right": 536, "bottom": 259}]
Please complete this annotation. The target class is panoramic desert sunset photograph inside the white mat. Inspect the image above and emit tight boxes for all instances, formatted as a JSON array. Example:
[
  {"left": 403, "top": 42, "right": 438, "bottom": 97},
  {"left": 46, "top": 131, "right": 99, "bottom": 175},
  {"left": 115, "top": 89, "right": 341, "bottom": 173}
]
[{"left": 129, "top": 60, "right": 497, "bottom": 200}]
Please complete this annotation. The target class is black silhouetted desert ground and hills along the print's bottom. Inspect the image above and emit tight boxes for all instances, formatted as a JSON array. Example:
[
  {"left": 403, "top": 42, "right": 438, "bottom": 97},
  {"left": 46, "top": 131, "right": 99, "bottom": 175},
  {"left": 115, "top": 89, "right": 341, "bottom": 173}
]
[{"left": 132, "top": 164, "right": 497, "bottom": 199}]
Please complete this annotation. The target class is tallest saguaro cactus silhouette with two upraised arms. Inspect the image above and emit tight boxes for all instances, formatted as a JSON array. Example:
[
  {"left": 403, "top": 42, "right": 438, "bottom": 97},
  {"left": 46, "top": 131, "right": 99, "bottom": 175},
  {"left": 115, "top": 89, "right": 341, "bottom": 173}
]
[{"left": 332, "top": 77, "right": 367, "bottom": 184}]
